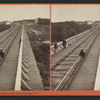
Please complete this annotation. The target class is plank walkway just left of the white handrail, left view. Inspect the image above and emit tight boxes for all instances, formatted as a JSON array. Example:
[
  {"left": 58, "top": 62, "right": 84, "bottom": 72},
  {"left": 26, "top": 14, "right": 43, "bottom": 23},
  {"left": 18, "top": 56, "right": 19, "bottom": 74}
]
[{"left": 0, "top": 27, "right": 21, "bottom": 91}]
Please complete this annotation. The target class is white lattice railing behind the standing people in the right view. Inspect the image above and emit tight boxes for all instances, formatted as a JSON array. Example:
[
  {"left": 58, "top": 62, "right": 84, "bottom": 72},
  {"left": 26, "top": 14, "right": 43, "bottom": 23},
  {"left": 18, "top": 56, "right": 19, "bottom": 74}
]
[{"left": 51, "top": 29, "right": 91, "bottom": 55}]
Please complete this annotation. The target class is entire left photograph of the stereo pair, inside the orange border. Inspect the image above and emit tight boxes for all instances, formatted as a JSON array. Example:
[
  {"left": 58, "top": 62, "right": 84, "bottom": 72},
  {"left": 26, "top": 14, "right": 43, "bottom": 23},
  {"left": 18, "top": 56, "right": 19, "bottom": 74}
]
[{"left": 0, "top": 5, "right": 50, "bottom": 91}]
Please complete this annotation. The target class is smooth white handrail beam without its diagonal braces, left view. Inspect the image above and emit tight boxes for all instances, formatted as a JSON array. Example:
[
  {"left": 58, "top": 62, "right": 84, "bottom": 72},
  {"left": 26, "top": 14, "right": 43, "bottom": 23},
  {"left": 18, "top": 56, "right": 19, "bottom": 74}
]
[{"left": 14, "top": 26, "right": 24, "bottom": 91}]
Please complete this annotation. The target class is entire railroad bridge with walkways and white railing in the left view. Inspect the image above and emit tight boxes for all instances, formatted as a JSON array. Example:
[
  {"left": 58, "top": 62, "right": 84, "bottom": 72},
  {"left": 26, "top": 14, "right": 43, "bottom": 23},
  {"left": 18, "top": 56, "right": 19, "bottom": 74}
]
[{"left": 0, "top": 23, "right": 44, "bottom": 91}]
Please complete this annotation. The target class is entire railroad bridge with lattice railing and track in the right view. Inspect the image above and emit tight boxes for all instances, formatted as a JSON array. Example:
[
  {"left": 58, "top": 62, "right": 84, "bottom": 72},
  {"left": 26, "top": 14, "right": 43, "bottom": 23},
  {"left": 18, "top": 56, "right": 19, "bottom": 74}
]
[{"left": 51, "top": 24, "right": 100, "bottom": 91}]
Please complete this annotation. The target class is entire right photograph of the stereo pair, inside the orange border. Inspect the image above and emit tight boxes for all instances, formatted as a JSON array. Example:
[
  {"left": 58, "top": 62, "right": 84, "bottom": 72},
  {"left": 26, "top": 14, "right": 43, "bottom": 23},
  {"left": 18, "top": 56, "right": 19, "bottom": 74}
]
[{"left": 51, "top": 4, "right": 100, "bottom": 91}]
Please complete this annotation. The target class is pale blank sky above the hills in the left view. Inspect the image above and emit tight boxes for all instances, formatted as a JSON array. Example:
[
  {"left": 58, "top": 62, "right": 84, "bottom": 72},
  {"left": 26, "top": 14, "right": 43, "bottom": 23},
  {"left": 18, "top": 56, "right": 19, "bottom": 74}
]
[{"left": 0, "top": 5, "right": 50, "bottom": 21}]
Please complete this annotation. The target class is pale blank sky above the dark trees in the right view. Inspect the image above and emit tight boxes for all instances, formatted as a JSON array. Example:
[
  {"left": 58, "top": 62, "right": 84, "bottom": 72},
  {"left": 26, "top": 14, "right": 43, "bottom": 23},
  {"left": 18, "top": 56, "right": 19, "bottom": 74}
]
[{"left": 51, "top": 5, "right": 100, "bottom": 22}]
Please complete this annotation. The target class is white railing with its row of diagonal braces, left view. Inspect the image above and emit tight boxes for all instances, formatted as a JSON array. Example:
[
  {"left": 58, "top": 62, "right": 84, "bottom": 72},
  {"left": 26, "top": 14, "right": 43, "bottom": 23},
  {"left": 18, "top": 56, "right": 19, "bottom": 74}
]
[{"left": 14, "top": 26, "right": 31, "bottom": 91}]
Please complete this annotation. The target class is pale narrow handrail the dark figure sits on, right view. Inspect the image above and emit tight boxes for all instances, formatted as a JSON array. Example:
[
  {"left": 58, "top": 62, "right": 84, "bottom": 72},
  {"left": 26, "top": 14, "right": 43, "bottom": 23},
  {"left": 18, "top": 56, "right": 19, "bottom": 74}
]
[{"left": 55, "top": 27, "right": 99, "bottom": 91}]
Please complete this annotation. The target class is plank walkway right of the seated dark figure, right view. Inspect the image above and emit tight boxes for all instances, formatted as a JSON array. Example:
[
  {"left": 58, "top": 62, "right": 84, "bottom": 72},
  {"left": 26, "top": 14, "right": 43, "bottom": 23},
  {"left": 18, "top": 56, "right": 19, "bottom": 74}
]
[{"left": 68, "top": 31, "right": 100, "bottom": 90}]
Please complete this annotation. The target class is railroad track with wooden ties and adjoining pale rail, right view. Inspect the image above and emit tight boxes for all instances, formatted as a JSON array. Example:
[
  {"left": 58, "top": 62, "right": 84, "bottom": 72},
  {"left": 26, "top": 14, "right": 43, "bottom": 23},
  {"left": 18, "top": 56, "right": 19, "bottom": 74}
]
[{"left": 51, "top": 25, "right": 100, "bottom": 91}]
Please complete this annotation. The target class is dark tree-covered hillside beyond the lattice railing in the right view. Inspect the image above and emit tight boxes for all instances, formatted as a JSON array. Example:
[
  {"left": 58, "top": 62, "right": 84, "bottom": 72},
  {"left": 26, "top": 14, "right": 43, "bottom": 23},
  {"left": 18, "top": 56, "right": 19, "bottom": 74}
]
[{"left": 51, "top": 21, "right": 92, "bottom": 42}]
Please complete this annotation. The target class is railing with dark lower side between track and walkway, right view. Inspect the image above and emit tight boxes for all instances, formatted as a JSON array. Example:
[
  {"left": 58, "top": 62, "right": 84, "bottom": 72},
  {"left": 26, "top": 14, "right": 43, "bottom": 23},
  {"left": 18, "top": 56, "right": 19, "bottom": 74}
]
[{"left": 55, "top": 26, "right": 99, "bottom": 91}]
